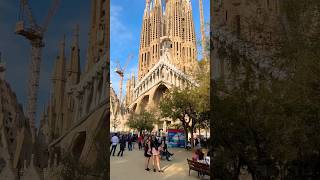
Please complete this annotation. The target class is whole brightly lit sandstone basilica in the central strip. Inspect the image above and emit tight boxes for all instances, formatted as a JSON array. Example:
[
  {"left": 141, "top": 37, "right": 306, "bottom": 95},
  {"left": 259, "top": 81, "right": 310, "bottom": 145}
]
[{"left": 111, "top": 0, "right": 198, "bottom": 131}]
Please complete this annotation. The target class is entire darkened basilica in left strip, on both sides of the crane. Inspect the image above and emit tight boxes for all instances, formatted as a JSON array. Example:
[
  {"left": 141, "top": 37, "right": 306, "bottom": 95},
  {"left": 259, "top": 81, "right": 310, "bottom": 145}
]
[{"left": 0, "top": 0, "right": 109, "bottom": 180}]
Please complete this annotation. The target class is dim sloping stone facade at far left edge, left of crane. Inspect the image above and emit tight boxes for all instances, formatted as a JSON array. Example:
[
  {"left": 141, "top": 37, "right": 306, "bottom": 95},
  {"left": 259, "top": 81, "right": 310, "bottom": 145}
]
[{"left": 0, "top": 75, "right": 32, "bottom": 179}]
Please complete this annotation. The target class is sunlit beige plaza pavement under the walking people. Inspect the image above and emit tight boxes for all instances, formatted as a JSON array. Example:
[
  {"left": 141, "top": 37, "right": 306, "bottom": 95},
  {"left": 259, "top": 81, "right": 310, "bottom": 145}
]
[{"left": 110, "top": 145, "right": 209, "bottom": 180}]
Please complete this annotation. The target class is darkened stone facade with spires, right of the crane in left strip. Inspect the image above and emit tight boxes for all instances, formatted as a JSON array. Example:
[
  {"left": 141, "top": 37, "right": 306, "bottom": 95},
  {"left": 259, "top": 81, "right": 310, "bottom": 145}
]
[{"left": 36, "top": 0, "right": 109, "bottom": 179}]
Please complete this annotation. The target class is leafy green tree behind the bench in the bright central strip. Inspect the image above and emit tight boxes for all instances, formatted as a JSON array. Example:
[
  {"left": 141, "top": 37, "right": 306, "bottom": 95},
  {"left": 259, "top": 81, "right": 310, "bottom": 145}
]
[{"left": 160, "top": 60, "right": 210, "bottom": 147}]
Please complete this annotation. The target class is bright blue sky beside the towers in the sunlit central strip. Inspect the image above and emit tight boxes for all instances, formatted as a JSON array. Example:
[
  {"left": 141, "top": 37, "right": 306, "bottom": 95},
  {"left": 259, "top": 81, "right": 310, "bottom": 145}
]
[{"left": 110, "top": 0, "right": 210, "bottom": 98}]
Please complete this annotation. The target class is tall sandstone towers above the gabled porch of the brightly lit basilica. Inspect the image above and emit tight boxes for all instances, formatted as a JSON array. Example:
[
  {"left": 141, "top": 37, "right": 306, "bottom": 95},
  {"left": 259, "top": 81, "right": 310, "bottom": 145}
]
[{"left": 138, "top": 0, "right": 197, "bottom": 80}]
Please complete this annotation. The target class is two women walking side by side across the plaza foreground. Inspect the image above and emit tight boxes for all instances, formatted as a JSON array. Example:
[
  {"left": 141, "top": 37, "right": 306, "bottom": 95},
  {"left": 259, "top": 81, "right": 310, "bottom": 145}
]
[{"left": 144, "top": 136, "right": 163, "bottom": 172}]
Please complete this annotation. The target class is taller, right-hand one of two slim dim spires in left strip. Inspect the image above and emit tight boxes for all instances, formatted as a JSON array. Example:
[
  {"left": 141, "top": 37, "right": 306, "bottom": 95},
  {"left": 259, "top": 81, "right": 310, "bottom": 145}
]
[{"left": 67, "top": 25, "right": 81, "bottom": 85}]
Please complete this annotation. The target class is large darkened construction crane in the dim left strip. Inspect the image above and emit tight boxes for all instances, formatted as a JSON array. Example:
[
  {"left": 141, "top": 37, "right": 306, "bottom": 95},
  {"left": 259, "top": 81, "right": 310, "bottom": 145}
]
[{"left": 15, "top": 0, "right": 60, "bottom": 142}]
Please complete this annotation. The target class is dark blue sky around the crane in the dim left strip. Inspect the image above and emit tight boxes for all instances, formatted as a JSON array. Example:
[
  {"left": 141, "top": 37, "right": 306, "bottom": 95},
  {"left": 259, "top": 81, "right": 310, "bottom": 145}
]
[{"left": 0, "top": 0, "right": 91, "bottom": 126}]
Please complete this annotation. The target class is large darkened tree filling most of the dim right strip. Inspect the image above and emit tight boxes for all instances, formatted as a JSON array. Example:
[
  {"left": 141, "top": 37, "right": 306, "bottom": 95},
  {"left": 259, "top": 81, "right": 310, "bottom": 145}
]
[{"left": 212, "top": 0, "right": 320, "bottom": 179}]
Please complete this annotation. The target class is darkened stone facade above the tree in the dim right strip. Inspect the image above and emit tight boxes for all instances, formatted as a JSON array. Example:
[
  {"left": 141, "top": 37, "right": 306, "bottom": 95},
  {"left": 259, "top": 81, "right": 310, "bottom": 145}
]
[{"left": 211, "top": 0, "right": 283, "bottom": 78}]
